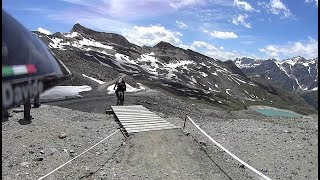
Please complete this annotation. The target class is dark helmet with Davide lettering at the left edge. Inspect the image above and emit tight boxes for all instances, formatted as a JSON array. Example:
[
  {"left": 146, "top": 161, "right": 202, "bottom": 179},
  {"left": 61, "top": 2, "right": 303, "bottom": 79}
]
[{"left": 2, "top": 10, "right": 71, "bottom": 109}]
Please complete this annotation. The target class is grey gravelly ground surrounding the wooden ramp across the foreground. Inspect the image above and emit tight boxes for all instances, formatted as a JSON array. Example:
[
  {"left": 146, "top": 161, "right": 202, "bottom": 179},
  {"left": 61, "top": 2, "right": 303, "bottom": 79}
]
[{"left": 2, "top": 83, "right": 318, "bottom": 179}]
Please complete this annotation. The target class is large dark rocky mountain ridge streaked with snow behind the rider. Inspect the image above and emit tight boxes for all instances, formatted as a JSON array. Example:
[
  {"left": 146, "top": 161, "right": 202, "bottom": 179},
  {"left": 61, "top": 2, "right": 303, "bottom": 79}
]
[{"left": 34, "top": 24, "right": 313, "bottom": 113}]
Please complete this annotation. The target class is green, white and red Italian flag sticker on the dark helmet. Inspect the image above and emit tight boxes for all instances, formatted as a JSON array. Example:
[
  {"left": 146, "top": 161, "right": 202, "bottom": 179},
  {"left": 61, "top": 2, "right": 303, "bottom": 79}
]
[{"left": 2, "top": 64, "right": 37, "bottom": 77}]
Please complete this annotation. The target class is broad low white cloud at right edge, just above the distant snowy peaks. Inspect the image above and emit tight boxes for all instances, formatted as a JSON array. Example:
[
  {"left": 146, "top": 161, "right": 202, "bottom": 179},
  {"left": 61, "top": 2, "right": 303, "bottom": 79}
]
[{"left": 259, "top": 37, "right": 318, "bottom": 58}]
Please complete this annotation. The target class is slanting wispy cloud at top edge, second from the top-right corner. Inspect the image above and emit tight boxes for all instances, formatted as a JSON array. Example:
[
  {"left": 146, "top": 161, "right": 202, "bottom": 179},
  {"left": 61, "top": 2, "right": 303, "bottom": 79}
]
[{"left": 258, "top": 0, "right": 293, "bottom": 18}]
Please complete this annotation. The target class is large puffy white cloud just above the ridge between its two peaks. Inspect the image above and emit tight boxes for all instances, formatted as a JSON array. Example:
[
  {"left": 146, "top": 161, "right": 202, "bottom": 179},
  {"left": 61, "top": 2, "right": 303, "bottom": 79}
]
[{"left": 124, "top": 25, "right": 182, "bottom": 46}]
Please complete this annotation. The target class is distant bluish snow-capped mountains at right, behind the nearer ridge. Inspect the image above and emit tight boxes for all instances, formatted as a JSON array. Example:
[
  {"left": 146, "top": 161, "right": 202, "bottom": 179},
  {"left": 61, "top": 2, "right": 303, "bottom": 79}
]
[{"left": 234, "top": 56, "right": 318, "bottom": 108}]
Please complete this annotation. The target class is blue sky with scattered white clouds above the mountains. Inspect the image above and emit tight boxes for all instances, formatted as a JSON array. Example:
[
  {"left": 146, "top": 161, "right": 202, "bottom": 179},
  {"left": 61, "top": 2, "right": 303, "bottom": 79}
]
[{"left": 2, "top": 0, "right": 318, "bottom": 60}]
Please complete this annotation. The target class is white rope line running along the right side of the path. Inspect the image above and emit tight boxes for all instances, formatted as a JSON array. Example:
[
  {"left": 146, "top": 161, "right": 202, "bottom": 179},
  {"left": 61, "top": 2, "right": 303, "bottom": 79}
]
[{"left": 186, "top": 116, "right": 271, "bottom": 180}]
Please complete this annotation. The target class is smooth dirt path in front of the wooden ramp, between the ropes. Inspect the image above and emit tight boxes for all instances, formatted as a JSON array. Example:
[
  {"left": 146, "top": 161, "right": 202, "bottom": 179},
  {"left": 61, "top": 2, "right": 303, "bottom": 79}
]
[{"left": 92, "top": 129, "right": 241, "bottom": 180}]
